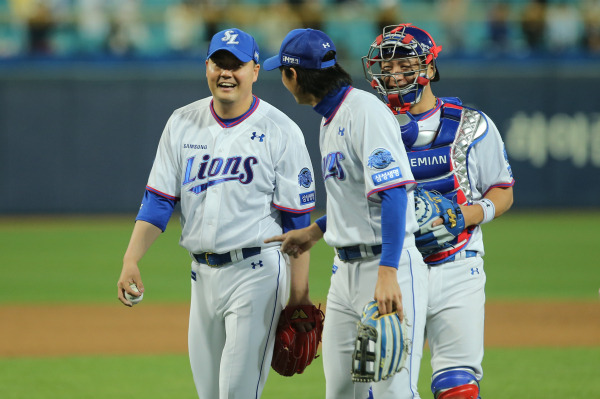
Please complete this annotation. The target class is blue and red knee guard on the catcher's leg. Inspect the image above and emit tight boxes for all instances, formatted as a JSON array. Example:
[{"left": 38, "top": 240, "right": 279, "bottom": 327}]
[{"left": 431, "top": 368, "right": 479, "bottom": 399}]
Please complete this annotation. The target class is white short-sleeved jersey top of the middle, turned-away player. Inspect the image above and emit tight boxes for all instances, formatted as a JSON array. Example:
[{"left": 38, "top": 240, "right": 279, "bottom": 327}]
[{"left": 320, "top": 88, "right": 418, "bottom": 247}]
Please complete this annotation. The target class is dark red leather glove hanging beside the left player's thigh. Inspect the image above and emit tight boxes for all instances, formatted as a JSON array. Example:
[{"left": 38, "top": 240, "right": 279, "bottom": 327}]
[{"left": 271, "top": 305, "right": 325, "bottom": 377}]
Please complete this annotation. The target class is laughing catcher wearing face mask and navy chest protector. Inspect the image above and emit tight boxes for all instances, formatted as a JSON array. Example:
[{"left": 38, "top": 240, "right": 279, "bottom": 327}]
[{"left": 363, "top": 24, "right": 514, "bottom": 399}]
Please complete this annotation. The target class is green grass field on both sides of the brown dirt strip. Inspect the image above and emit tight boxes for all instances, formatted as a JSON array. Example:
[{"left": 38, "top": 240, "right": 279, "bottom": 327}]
[{"left": 0, "top": 211, "right": 600, "bottom": 399}]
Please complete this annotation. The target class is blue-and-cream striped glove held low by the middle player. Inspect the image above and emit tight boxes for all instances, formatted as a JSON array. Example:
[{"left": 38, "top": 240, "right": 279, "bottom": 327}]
[{"left": 352, "top": 301, "right": 410, "bottom": 382}]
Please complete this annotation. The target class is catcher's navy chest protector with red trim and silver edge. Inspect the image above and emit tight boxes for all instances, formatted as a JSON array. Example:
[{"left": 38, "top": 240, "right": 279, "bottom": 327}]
[{"left": 402, "top": 97, "right": 488, "bottom": 264}]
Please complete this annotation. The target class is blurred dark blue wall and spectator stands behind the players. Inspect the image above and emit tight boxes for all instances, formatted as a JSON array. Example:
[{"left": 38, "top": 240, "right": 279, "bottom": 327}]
[{"left": 0, "top": 0, "right": 600, "bottom": 214}]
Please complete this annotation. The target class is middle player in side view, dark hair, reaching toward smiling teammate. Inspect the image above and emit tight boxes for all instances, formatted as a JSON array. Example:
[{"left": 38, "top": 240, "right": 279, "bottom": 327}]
[{"left": 263, "top": 29, "right": 427, "bottom": 399}]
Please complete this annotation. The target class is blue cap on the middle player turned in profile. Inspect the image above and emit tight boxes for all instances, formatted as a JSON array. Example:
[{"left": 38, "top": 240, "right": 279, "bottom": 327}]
[{"left": 263, "top": 29, "right": 336, "bottom": 71}]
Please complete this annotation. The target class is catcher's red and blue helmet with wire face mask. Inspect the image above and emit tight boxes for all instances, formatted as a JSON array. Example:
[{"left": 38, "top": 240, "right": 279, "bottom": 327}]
[{"left": 362, "top": 24, "right": 442, "bottom": 112}]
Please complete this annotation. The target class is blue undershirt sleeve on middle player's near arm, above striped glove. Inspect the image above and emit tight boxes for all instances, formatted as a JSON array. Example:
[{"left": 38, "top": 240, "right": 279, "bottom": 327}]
[{"left": 379, "top": 186, "right": 408, "bottom": 269}]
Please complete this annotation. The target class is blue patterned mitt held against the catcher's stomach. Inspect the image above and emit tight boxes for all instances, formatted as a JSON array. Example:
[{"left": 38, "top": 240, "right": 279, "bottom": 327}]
[{"left": 415, "top": 187, "right": 465, "bottom": 256}]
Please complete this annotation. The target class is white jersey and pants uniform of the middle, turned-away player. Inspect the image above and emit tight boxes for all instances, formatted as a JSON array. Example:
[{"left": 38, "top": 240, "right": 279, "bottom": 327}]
[{"left": 320, "top": 88, "right": 427, "bottom": 399}]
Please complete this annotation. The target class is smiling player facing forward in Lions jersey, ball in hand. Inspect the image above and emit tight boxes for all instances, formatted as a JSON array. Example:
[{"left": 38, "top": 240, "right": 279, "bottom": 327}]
[{"left": 118, "top": 29, "right": 315, "bottom": 399}]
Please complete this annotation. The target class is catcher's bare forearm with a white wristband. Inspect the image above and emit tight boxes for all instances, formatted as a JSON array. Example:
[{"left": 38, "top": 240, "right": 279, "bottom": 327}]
[{"left": 460, "top": 186, "right": 513, "bottom": 226}]
